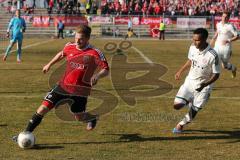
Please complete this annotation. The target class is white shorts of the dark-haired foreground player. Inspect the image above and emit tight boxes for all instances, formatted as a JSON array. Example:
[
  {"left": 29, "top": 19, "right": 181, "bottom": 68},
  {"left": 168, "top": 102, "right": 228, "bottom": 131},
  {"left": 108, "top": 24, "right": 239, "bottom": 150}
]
[{"left": 174, "top": 79, "right": 212, "bottom": 109}]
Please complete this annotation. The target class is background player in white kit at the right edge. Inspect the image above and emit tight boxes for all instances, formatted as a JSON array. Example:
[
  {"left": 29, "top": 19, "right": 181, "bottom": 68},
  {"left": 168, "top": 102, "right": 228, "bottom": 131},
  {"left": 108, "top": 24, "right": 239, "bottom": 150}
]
[{"left": 210, "top": 12, "right": 239, "bottom": 78}]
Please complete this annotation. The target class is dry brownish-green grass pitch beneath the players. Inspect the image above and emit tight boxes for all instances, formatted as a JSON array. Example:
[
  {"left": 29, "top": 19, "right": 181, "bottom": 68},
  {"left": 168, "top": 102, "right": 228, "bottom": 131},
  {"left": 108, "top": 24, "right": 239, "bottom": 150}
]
[{"left": 0, "top": 38, "right": 240, "bottom": 160}]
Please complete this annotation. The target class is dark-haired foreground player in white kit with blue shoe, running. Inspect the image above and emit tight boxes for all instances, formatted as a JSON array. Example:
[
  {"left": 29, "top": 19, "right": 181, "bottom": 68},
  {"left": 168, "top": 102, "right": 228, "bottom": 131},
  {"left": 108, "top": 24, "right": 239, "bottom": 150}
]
[{"left": 173, "top": 28, "right": 221, "bottom": 133}]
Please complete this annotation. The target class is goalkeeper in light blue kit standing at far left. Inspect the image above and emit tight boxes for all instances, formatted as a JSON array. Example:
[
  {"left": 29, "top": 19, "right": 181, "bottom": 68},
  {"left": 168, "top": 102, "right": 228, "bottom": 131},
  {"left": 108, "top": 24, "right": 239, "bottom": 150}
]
[{"left": 3, "top": 10, "right": 26, "bottom": 62}]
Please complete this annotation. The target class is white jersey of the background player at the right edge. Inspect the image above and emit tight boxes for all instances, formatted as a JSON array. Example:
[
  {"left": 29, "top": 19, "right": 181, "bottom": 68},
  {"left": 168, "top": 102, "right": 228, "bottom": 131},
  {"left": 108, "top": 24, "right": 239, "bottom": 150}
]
[{"left": 215, "top": 22, "right": 238, "bottom": 46}]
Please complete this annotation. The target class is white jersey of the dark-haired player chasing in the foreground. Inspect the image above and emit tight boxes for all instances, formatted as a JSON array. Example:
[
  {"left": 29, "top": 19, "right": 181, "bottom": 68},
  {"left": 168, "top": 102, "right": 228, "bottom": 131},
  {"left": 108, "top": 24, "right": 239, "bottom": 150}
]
[{"left": 186, "top": 45, "right": 220, "bottom": 85}]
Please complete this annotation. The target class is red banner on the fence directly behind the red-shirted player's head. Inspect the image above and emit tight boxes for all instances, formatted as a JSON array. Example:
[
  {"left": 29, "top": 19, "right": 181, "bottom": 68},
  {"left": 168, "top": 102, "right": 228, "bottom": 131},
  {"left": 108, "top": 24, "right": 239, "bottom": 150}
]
[{"left": 54, "top": 16, "right": 88, "bottom": 27}]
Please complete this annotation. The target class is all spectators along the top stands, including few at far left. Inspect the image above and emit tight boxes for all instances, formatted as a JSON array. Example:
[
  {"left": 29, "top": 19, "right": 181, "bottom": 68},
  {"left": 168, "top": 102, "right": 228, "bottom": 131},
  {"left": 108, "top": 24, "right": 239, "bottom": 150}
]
[{"left": 3, "top": 0, "right": 240, "bottom": 17}]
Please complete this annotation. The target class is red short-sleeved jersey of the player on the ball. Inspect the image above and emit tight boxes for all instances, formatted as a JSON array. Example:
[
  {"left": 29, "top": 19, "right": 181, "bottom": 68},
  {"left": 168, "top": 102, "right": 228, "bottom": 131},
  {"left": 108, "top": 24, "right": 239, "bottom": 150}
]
[{"left": 59, "top": 43, "right": 109, "bottom": 96}]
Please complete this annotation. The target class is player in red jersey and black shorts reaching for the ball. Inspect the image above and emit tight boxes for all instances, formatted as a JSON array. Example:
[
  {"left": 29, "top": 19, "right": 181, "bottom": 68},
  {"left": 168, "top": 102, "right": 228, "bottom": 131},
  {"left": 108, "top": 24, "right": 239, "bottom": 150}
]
[{"left": 15, "top": 25, "right": 109, "bottom": 139}]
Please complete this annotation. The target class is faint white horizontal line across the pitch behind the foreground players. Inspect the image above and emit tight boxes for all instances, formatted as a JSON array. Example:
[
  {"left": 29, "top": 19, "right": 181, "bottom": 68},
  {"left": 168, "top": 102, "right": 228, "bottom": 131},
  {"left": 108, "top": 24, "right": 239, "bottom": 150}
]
[{"left": 0, "top": 95, "right": 240, "bottom": 100}]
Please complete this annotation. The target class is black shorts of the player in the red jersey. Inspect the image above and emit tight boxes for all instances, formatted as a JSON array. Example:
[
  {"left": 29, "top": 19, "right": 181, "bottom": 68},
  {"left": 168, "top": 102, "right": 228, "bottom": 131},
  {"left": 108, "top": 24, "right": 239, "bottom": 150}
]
[{"left": 42, "top": 86, "right": 87, "bottom": 113}]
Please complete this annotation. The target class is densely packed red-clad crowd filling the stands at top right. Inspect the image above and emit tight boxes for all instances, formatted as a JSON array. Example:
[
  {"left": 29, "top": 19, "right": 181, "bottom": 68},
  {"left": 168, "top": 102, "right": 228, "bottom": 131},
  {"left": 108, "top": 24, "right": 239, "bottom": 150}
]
[{"left": 101, "top": 0, "right": 240, "bottom": 16}]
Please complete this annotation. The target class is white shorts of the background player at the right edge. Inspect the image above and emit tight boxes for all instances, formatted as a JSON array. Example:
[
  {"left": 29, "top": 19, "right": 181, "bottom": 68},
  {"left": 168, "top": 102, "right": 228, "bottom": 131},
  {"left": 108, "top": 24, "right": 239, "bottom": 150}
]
[{"left": 214, "top": 45, "right": 232, "bottom": 65}]
